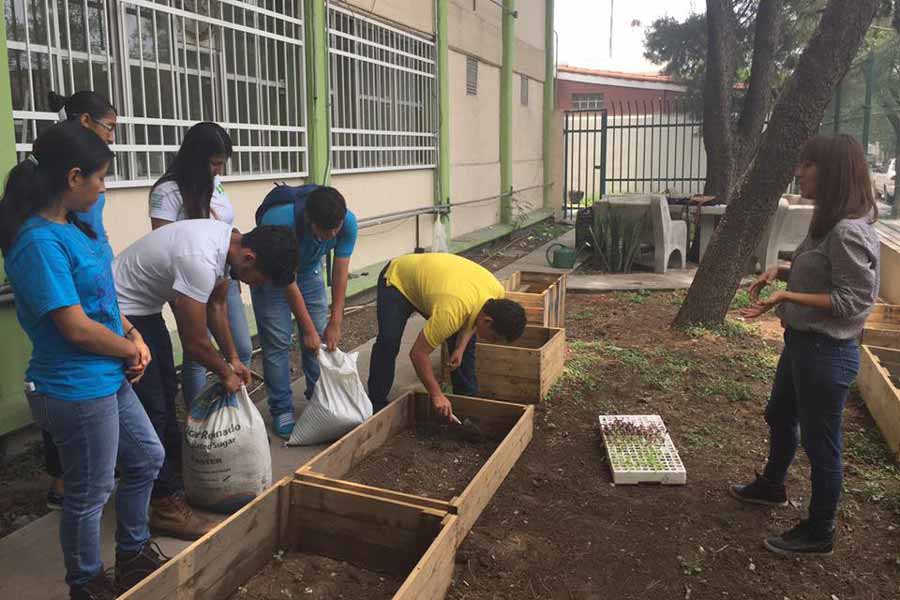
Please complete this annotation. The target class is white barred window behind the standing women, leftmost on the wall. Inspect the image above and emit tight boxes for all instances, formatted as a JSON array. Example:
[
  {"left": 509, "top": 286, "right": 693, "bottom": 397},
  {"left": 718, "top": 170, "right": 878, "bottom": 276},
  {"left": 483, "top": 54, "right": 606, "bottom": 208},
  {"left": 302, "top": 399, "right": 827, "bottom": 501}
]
[{"left": 6, "top": 0, "right": 306, "bottom": 187}]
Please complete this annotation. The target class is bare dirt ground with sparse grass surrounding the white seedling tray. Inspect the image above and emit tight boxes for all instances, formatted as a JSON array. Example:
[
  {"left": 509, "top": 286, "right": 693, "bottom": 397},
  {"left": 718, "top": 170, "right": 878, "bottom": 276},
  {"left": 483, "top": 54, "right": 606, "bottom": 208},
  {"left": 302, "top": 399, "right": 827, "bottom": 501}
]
[{"left": 448, "top": 292, "right": 900, "bottom": 600}]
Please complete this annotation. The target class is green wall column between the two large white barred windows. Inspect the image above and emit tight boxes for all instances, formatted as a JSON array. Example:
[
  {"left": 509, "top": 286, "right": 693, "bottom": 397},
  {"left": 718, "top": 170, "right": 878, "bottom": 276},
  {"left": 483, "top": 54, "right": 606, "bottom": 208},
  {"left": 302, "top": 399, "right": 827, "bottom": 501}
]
[{"left": 303, "top": 0, "right": 331, "bottom": 185}]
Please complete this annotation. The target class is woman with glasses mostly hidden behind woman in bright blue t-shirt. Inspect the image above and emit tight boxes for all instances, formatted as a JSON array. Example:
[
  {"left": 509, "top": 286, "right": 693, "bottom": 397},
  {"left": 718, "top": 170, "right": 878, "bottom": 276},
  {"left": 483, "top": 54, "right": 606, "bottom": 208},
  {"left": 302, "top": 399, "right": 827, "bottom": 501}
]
[{"left": 42, "top": 90, "right": 118, "bottom": 510}]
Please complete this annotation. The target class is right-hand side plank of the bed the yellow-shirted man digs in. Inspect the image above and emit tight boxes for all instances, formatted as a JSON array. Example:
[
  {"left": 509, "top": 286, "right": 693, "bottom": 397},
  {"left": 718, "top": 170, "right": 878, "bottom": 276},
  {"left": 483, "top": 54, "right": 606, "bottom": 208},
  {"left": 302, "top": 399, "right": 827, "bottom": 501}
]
[{"left": 452, "top": 406, "right": 534, "bottom": 541}]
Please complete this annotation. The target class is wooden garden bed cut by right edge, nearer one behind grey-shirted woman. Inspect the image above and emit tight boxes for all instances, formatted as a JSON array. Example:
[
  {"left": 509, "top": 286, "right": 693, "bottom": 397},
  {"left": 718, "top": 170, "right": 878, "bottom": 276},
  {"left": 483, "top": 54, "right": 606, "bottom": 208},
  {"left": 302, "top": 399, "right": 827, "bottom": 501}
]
[{"left": 857, "top": 346, "right": 900, "bottom": 459}]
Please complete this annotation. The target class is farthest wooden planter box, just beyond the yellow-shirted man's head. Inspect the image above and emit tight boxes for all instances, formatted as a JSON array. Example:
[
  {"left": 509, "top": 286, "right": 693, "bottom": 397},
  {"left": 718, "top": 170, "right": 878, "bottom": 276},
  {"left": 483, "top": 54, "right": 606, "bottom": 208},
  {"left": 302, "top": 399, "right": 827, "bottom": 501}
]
[{"left": 501, "top": 271, "right": 567, "bottom": 327}]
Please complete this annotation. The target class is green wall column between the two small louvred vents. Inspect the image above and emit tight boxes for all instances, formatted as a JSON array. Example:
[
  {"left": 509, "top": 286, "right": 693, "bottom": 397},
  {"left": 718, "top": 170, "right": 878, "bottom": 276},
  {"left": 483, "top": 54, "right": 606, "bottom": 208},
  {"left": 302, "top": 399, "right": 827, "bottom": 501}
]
[{"left": 500, "top": 0, "right": 516, "bottom": 224}]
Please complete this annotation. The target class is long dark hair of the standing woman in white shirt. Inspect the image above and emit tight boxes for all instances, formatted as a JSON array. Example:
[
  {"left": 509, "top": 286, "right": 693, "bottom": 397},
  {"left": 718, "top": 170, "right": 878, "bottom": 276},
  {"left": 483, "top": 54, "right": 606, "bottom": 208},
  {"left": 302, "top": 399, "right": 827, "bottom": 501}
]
[{"left": 150, "top": 121, "right": 232, "bottom": 219}]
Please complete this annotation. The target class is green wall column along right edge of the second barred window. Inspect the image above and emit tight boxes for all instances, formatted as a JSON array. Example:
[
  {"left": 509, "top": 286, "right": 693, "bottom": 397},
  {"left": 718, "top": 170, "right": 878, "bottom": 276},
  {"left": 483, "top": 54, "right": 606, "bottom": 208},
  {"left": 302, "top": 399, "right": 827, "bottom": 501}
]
[{"left": 434, "top": 0, "right": 451, "bottom": 240}]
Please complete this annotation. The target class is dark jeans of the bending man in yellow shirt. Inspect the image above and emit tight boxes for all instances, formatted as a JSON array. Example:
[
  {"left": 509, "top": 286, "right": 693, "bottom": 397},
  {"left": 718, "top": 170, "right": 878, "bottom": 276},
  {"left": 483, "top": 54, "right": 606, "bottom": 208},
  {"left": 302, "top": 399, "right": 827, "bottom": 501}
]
[{"left": 369, "top": 267, "right": 478, "bottom": 412}]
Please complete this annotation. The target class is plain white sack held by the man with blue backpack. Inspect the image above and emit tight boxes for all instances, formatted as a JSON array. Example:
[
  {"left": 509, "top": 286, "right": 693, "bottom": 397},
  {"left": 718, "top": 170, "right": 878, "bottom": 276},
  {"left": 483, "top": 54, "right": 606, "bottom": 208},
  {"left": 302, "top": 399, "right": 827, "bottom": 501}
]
[{"left": 287, "top": 346, "right": 372, "bottom": 446}]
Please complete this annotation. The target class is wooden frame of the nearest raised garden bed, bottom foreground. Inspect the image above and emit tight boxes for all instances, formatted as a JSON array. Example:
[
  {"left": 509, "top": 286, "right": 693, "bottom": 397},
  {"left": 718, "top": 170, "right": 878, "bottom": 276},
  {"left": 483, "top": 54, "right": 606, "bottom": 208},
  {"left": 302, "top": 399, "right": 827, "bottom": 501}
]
[{"left": 119, "top": 477, "right": 458, "bottom": 600}]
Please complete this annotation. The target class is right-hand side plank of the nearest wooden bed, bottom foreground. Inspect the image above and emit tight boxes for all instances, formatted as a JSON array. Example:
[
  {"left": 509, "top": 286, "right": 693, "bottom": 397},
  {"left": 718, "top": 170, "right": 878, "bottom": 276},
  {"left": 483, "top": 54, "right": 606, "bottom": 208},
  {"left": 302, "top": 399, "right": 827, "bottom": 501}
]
[{"left": 393, "top": 515, "right": 460, "bottom": 600}]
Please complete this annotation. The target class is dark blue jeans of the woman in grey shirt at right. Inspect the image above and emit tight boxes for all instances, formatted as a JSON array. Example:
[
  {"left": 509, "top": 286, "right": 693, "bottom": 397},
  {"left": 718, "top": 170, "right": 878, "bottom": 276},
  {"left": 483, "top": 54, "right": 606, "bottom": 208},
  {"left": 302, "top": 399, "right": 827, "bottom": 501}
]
[{"left": 763, "top": 329, "right": 859, "bottom": 530}]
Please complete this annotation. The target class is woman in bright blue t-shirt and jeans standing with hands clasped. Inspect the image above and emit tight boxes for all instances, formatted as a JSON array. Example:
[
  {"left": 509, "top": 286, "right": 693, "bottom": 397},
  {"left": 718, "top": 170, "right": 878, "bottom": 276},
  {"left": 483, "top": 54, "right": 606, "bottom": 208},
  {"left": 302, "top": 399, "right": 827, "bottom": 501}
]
[{"left": 0, "top": 122, "right": 163, "bottom": 599}]
